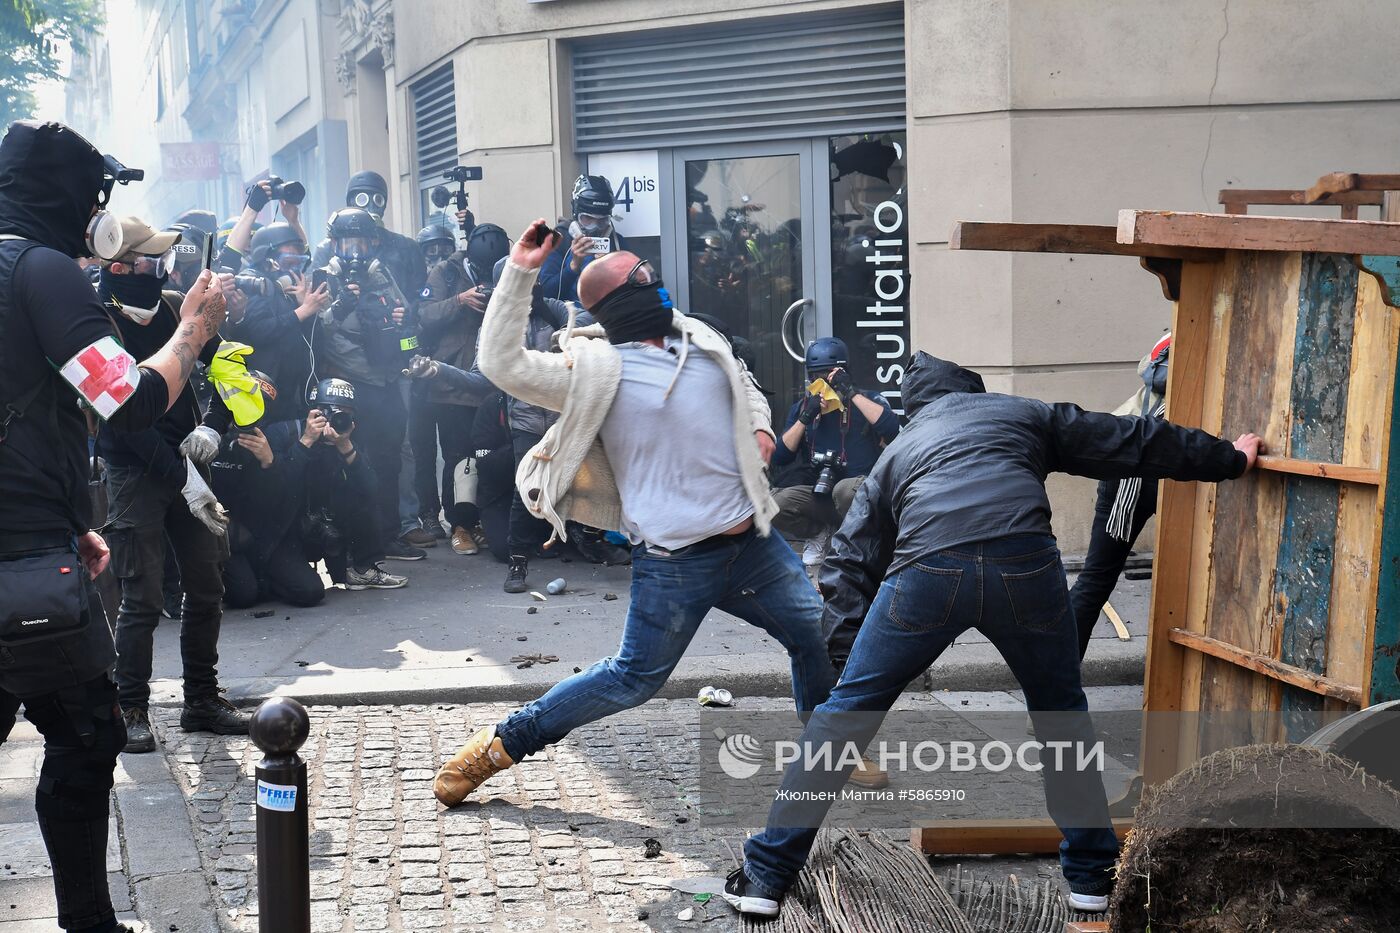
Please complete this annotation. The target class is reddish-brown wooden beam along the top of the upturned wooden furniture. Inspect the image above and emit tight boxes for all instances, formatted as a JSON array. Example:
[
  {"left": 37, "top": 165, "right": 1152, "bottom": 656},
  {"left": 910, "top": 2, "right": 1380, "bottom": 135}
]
[{"left": 1117, "top": 210, "right": 1400, "bottom": 256}]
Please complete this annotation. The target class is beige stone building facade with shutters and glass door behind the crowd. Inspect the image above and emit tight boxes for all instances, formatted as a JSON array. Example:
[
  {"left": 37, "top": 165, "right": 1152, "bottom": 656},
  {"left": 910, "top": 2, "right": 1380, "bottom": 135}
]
[{"left": 68, "top": 0, "right": 1400, "bottom": 551}]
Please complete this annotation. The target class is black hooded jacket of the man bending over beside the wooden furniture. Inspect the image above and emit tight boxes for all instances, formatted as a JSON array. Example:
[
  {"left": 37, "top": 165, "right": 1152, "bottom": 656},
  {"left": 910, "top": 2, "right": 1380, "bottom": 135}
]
[{"left": 820, "top": 352, "right": 1246, "bottom": 664}]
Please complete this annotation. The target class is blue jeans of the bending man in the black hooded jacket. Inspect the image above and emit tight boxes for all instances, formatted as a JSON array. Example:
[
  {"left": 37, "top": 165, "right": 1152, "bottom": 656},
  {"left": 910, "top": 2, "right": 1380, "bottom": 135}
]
[{"left": 743, "top": 535, "right": 1119, "bottom": 894}]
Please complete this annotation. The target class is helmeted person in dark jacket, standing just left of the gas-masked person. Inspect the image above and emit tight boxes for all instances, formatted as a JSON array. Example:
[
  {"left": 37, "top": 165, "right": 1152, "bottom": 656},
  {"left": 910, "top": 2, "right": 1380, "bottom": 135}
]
[{"left": 225, "top": 223, "right": 330, "bottom": 422}]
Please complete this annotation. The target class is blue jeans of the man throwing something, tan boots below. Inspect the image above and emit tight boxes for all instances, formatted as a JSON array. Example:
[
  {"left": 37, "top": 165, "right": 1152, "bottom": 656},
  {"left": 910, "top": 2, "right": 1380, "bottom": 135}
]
[{"left": 497, "top": 530, "right": 836, "bottom": 761}]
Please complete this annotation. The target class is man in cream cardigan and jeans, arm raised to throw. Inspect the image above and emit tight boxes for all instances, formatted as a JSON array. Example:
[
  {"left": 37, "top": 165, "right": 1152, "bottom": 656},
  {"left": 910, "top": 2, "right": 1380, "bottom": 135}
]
[{"left": 433, "top": 221, "right": 834, "bottom": 807}]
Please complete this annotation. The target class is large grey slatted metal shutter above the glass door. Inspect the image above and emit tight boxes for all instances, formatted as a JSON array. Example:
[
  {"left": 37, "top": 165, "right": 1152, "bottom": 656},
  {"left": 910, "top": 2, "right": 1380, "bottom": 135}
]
[{"left": 573, "top": 7, "right": 904, "bottom": 153}]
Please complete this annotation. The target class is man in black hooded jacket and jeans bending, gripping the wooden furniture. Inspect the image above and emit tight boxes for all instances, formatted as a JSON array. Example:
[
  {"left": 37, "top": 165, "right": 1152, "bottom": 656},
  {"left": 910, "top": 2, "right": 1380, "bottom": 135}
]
[{"left": 725, "top": 353, "right": 1260, "bottom": 916}]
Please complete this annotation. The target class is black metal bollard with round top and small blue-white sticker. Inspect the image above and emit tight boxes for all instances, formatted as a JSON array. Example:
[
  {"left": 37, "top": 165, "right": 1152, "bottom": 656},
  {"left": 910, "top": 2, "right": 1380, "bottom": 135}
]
[{"left": 248, "top": 696, "right": 311, "bottom": 933}]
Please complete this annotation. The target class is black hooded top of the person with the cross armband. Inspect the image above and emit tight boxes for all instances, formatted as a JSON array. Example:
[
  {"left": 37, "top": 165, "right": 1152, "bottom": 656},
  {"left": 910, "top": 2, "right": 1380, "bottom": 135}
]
[{"left": 0, "top": 123, "right": 167, "bottom": 535}]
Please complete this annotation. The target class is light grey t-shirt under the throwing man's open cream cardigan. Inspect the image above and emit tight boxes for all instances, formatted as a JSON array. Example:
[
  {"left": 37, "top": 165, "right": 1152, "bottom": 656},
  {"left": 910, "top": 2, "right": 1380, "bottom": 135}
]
[{"left": 599, "top": 339, "right": 753, "bottom": 551}]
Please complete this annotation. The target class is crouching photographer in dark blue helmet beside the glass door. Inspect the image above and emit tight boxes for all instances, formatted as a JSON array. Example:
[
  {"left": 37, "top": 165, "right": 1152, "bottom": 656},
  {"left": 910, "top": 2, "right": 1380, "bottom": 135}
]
[{"left": 773, "top": 338, "right": 899, "bottom": 565}]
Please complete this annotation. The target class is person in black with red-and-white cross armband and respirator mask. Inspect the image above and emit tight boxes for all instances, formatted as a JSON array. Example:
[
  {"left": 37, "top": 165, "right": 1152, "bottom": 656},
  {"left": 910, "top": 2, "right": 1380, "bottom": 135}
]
[{"left": 0, "top": 122, "right": 224, "bottom": 933}]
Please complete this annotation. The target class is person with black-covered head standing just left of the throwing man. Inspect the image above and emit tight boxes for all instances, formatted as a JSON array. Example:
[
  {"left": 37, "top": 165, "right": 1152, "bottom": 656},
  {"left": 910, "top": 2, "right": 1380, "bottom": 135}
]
[{"left": 416, "top": 224, "right": 511, "bottom": 555}]
